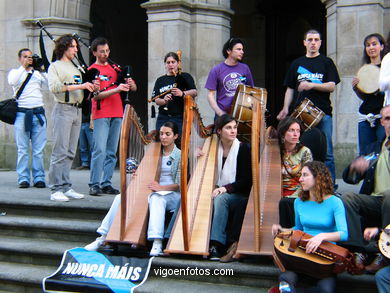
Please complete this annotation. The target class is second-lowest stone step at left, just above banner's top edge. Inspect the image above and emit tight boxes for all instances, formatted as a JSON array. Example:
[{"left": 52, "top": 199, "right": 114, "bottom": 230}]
[{"left": 0, "top": 236, "right": 86, "bottom": 268}]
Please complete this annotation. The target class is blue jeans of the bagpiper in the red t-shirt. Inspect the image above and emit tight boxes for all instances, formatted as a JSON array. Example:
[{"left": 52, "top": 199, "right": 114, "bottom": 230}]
[{"left": 89, "top": 118, "right": 122, "bottom": 187}]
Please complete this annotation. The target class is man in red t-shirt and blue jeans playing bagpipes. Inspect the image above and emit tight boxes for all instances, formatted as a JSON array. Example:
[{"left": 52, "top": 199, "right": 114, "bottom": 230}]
[{"left": 89, "top": 38, "right": 137, "bottom": 196}]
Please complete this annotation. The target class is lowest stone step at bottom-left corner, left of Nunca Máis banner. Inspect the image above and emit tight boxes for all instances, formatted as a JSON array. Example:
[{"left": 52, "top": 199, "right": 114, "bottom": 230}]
[{"left": 0, "top": 261, "right": 55, "bottom": 293}]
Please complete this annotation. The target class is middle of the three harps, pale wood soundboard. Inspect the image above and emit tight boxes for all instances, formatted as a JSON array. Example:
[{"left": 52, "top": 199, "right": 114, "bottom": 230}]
[{"left": 165, "top": 96, "right": 213, "bottom": 255}]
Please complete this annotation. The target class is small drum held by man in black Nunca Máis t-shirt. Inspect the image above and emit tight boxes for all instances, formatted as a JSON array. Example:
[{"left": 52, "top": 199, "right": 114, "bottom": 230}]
[{"left": 291, "top": 98, "right": 325, "bottom": 131}]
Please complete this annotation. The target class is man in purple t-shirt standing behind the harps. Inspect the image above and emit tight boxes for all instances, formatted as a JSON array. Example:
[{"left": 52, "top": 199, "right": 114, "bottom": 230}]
[{"left": 205, "top": 38, "right": 254, "bottom": 116}]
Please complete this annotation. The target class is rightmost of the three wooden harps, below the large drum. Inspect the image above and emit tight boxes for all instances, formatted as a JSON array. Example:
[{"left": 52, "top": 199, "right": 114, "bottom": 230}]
[{"left": 235, "top": 89, "right": 282, "bottom": 257}]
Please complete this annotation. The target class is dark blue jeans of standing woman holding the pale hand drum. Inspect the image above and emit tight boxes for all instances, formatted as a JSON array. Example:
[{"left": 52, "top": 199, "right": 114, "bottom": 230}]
[{"left": 358, "top": 119, "right": 386, "bottom": 156}]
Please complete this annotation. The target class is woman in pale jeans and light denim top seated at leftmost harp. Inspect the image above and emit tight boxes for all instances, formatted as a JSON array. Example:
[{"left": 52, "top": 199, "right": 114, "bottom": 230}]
[{"left": 85, "top": 122, "right": 181, "bottom": 256}]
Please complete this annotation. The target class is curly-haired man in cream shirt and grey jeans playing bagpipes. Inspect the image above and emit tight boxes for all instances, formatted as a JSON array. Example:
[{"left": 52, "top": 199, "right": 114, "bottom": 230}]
[{"left": 48, "top": 35, "right": 98, "bottom": 201}]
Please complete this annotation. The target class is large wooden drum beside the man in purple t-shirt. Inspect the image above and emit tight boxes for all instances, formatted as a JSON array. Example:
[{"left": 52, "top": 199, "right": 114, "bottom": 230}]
[{"left": 231, "top": 84, "right": 267, "bottom": 140}]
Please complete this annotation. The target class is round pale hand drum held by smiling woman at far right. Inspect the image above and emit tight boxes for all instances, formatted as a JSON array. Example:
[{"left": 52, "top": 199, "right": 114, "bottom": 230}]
[{"left": 356, "top": 64, "right": 380, "bottom": 94}]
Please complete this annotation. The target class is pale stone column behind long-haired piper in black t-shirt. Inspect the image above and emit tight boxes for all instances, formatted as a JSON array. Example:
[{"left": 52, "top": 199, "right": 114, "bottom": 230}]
[{"left": 142, "top": 0, "right": 233, "bottom": 129}]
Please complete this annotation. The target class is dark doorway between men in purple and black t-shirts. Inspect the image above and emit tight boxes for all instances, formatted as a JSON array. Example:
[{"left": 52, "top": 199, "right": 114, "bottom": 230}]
[{"left": 231, "top": 0, "right": 326, "bottom": 125}]
